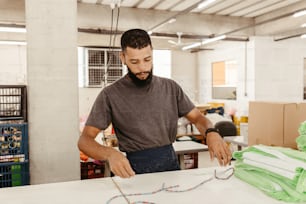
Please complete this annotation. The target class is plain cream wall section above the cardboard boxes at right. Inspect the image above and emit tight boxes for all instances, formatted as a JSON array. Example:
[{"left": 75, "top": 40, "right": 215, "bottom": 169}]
[{"left": 254, "top": 37, "right": 306, "bottom": 102}]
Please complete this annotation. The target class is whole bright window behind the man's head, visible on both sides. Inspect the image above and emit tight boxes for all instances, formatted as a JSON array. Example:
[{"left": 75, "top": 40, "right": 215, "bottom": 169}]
[{"left": 78, "top": 47, "right": 171, "bottom": 87}]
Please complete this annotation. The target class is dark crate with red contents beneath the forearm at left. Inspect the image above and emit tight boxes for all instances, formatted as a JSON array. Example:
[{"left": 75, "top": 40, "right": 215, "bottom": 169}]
[{"left": 81, "top": 161, "right": 105, "bottom": 179}]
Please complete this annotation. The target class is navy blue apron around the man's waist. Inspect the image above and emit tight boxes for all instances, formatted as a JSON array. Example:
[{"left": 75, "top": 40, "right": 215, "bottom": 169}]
[{"left": 126, "top": 144, "right": 180, "bottom": 174}]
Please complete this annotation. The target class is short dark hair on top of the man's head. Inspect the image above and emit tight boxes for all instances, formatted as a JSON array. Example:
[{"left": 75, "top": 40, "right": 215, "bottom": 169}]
[{"left": 121, "top": 29, "right": 152, "bottom": 51}]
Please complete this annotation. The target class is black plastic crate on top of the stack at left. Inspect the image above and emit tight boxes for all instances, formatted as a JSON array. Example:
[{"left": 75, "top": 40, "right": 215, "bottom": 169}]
[{"left": 0, "top": 85, "right": 27, "bottom": 122}]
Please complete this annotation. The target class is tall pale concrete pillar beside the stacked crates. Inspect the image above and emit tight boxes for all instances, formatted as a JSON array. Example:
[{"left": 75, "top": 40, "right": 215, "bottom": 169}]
[{"left": 26, "top": 0, "right": 80, "bottom": 184}]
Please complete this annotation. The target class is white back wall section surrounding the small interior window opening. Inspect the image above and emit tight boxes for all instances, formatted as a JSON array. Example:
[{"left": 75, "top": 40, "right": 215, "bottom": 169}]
[{"left": 197, "top": 41, "right": 253, "bottom": 114}]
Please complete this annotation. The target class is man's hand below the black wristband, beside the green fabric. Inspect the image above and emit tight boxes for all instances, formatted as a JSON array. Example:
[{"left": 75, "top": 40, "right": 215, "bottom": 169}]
[{"left": 206, "top": 132, "right": 232, "bottom": 166}]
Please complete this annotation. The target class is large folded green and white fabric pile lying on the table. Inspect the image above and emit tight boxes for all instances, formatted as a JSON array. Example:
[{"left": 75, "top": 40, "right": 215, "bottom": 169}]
[{"left": 233, "top": 145, "right": 306, "bottom": 203}]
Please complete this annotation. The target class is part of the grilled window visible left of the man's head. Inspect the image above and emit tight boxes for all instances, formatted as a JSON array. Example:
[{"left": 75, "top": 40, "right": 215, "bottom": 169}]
[{"left": 78, "top": 48, "right": 123, "bottom": 87}]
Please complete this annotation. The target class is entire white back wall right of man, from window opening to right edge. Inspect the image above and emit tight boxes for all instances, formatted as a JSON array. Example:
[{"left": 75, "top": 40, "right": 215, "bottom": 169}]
[{"left": 198, "top": 37, "right": 306, "bottom": 115}]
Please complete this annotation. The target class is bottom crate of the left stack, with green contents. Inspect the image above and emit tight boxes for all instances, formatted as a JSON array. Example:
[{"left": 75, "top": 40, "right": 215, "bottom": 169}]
[{"left": 0, "top": 162, "right": 30, "bottom": 188}]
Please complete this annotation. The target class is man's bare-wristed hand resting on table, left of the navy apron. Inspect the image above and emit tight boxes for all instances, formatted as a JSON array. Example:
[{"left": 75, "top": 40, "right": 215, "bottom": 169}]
[{"left": 108, "top": 149, "right": 135, "bottom": 178}]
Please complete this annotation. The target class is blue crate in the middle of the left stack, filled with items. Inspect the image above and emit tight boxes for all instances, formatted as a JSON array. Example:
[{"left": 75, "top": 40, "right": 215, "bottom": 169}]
[{"left": 0, "top": 123, "right": 28, "bottom": 158}]
